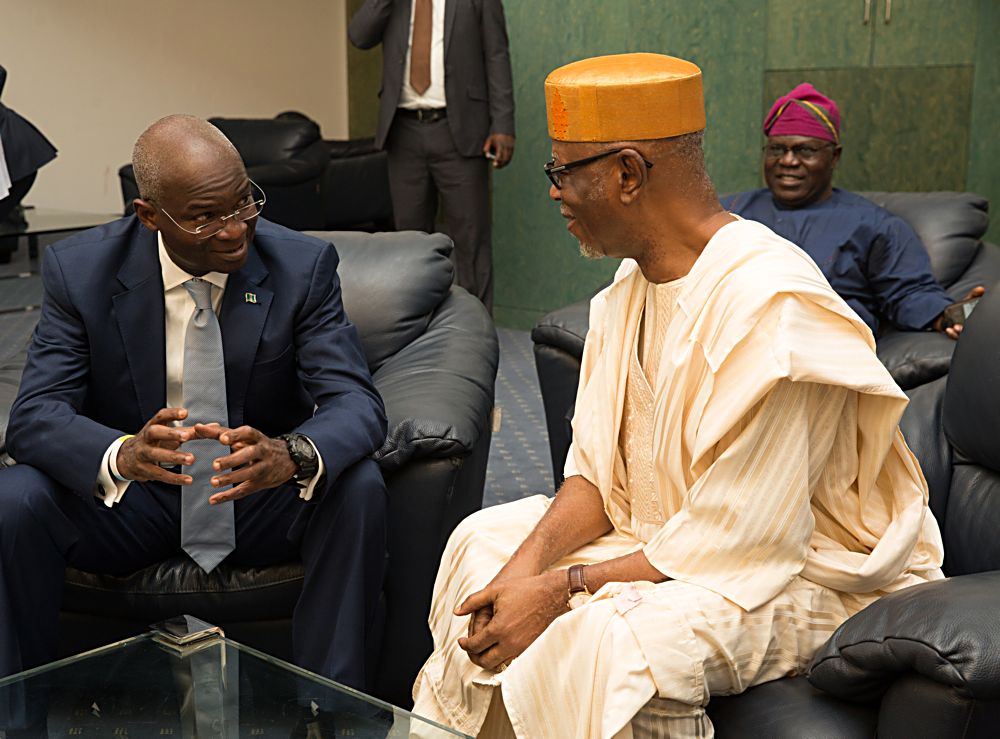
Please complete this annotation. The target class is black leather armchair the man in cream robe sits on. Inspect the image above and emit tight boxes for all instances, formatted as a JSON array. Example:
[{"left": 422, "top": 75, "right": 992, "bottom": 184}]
[{"left": 708, "top": 291, "right": 1000, "bottom": 739}]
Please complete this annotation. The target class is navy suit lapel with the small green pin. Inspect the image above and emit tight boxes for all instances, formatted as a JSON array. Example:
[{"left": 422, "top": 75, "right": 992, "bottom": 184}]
[{"left": 219, "top": 244, "right": 274, "bottom": 428}]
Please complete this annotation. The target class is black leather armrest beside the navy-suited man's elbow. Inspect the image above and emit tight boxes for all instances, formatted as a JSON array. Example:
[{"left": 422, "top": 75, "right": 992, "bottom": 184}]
[{"left": 373, "top": 287, "right": 500, "bottom": 473}]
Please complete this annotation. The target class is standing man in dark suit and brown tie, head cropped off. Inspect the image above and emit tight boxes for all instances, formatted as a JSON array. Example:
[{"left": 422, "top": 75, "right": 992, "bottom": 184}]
[{"left": 348, "top": 0, "right": 514, "bottom": 311}]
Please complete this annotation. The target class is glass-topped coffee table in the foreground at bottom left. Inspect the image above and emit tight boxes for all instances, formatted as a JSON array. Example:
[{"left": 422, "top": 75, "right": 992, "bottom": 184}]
[{"left": 0, "top": 631, "right": 465, "bottom": 739}]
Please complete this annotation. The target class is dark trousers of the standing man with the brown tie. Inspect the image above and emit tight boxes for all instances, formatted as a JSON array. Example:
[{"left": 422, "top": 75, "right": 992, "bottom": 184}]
[{"left": 385, "top": 115, "right": 493, "bottom": 313}]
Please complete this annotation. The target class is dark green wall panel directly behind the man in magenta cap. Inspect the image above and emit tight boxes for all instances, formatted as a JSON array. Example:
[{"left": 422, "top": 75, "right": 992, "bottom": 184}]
[{"left": 762, "top": 66, "right": 973, "bottom": 190}]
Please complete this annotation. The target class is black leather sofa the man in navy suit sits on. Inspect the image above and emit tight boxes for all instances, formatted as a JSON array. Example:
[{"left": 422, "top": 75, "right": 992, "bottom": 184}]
[{"left": 0, "top": 232, "right": 499, "bottom": 706}]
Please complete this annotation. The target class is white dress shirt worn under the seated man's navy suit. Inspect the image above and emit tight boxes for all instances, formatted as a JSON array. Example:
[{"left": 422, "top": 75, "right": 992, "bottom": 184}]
[{"left": 95, "top": 233, "right": 324, "bottom": 508}]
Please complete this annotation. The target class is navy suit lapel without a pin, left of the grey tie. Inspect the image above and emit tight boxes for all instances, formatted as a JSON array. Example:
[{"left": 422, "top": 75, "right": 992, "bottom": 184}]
[{"left": 112, "top": 226, "right": 167, "bottom": 420}]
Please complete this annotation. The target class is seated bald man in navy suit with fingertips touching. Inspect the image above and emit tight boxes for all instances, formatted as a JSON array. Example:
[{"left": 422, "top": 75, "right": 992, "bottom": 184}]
[{"left": 0, "top": 116, "right": 386, "bottom": 688}]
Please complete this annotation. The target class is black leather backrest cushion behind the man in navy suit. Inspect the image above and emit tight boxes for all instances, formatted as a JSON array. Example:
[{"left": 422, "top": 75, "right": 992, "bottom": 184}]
[{"left": 309, "top": 231, "right": 454, "bottom": 372}]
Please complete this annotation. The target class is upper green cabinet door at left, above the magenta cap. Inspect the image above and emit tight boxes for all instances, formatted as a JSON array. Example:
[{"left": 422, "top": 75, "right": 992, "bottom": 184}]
[{"left": 767, "top": 0, "right": 876, "bottom": 69}]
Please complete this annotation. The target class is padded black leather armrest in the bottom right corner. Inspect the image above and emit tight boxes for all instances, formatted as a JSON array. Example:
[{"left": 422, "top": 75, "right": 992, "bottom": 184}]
[{"left": 809, "top": 570, "right": 1000, "bottom": 702}]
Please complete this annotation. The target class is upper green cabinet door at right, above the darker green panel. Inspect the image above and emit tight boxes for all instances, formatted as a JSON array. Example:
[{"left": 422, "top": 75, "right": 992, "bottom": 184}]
[{"left": 876, "top": 0, "right": 976, "bottom": 67}]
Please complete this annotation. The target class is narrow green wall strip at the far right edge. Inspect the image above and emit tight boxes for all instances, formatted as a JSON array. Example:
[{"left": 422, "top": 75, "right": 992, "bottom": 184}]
[{"left": 967, "top": 0, "right": 1000, "bottom": 244}]
